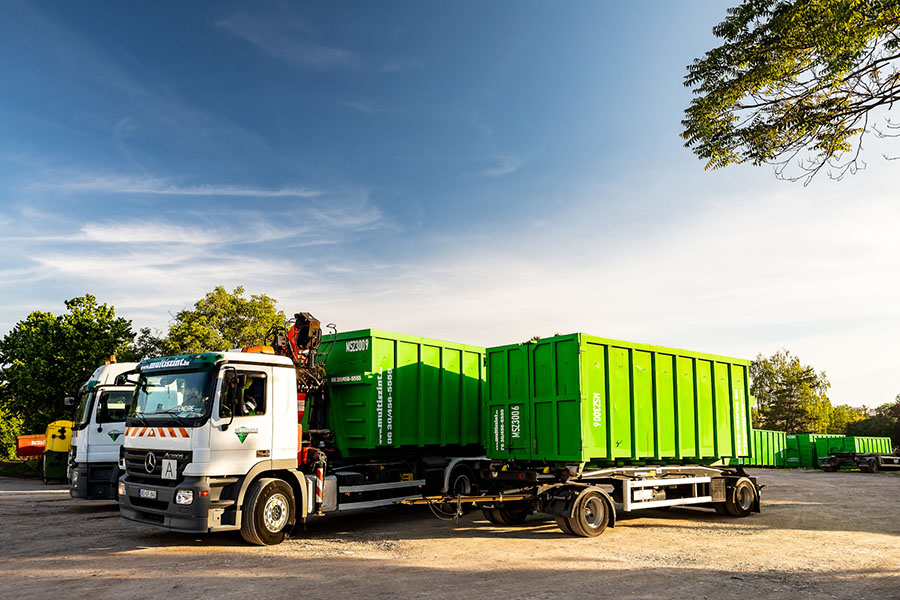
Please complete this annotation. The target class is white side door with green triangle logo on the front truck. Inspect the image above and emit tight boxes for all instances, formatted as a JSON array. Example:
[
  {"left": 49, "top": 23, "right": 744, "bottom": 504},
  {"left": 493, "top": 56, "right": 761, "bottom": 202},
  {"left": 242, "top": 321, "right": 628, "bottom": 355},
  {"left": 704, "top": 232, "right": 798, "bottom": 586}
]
[{"left": 209, "top": 365, "right": 274, "bottom": 475}]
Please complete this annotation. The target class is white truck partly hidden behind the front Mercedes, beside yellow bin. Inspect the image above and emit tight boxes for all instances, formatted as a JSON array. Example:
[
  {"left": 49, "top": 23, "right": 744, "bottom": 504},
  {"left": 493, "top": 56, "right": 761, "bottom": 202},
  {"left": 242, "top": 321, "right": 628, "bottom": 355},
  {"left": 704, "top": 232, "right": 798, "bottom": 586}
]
[{"left": 67, "top": 362, "right": 138, "bottom": 500}]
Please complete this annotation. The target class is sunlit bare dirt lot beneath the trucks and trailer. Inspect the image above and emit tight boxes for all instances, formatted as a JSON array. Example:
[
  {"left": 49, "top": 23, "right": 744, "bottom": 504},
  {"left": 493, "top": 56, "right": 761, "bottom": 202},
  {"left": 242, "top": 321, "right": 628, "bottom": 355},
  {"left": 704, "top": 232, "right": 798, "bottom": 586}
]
[{"left": 0, "top": 470, "right": 900, "bottom": 600}]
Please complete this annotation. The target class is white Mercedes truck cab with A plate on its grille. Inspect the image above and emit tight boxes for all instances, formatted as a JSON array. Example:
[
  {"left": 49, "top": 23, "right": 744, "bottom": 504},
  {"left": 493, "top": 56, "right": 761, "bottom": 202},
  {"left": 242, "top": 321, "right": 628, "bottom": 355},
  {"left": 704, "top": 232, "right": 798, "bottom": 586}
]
[{"left": 118, "top": 351, "right": 308, "bottom": 543}]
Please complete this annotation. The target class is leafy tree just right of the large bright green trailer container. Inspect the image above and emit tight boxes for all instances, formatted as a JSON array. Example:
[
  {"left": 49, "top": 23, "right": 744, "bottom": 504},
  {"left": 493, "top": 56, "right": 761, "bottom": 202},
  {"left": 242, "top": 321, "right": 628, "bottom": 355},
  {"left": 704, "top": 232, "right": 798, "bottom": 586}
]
[{"left": 750, "top": 349, "right": 832, "bottom": 433}]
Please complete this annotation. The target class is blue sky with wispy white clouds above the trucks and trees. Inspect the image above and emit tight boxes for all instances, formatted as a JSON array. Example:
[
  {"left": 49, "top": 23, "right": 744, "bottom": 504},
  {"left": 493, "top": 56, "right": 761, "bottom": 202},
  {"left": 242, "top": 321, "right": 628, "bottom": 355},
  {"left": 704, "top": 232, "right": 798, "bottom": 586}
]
[{"left": 0, "top": 1, "right": 900, "bottom": 406}]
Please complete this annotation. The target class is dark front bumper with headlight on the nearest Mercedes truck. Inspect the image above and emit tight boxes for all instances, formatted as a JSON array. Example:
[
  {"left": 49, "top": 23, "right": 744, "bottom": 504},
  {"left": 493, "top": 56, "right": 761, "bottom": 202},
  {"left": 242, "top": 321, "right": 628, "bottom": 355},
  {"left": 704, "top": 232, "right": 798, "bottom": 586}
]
[{"left": 119, "top": 475, "right": 240, "bottom": 533}]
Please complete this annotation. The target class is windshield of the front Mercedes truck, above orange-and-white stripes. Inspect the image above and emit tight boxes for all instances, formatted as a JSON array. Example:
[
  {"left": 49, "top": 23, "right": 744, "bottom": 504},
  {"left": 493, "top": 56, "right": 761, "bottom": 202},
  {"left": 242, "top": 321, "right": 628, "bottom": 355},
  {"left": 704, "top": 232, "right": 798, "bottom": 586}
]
[{"left": 128, "top": 371, "right": 212, "bottom": 426}]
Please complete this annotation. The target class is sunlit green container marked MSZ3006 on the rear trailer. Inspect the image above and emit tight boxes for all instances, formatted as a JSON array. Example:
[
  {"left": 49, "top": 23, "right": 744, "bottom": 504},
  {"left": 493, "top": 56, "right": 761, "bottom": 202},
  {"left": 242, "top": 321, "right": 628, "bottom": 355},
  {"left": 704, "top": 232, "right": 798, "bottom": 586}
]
[{"left": 484, "top": 333, "right": 750, "bottom": 466}]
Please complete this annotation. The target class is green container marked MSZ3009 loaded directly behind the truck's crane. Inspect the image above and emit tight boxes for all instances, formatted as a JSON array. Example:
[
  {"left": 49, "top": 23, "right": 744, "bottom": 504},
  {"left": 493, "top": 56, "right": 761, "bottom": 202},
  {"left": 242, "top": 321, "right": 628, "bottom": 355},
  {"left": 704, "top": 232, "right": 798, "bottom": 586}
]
[{"left": 324, "top": 329, "right": 484, "bottom": 458}]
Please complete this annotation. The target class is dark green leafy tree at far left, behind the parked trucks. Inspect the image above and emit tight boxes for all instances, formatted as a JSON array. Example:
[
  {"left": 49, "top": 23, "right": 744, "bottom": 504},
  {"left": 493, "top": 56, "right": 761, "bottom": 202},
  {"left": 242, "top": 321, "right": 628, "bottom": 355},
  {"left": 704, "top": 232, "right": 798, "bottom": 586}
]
[{"left": 0, "top": 294, "right": 134, "bottom": 433}]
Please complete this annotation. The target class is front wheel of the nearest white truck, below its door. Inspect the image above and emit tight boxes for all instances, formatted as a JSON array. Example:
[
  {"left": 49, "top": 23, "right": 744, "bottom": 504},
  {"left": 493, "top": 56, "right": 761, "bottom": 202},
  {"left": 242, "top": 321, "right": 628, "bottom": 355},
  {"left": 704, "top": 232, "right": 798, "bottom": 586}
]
[{"left": 241, "top": 479, "right": 294, "bottom": 546}]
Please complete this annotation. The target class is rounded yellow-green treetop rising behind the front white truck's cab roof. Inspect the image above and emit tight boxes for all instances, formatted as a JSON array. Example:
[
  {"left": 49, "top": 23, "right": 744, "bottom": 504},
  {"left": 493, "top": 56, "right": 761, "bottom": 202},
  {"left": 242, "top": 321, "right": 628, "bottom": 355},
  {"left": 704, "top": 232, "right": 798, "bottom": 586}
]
[{"left": 160, "top": 286, "right": 286, "bottom": 354}]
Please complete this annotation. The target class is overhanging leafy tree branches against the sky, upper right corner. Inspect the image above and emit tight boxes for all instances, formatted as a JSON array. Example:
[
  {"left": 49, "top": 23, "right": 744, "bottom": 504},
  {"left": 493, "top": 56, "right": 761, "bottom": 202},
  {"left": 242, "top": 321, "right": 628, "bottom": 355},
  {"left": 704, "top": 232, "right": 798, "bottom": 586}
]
[{"left": 682, "top": 0, "right": 900, "bottom": 183}]
